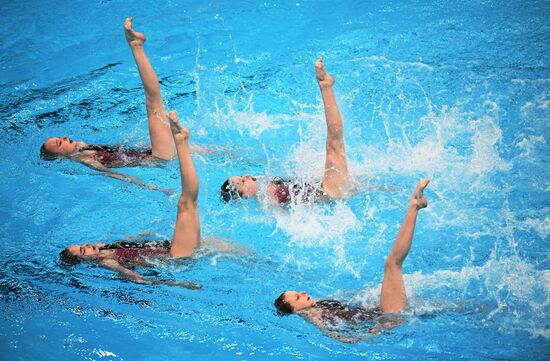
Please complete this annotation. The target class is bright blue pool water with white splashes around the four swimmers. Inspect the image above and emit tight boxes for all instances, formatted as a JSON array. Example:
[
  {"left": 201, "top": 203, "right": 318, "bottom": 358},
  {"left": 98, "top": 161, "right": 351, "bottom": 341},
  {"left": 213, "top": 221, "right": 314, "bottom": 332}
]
[{"left": 0, "top": 0, "right": 550, "bottom": 360}]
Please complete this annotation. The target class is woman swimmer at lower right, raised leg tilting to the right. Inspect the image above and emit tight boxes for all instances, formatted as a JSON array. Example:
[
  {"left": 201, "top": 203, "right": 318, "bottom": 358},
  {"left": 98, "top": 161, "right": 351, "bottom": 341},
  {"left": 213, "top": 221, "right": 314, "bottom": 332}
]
[{"left": 275, "top": 179, "right": 430, "bottom": 342}]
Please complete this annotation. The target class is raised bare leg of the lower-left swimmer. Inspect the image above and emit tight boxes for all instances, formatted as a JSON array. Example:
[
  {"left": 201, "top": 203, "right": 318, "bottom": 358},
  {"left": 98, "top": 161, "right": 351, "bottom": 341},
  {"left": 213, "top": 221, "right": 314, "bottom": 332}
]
[{"left": 169, "top": 111, "right": 201, "bottom": 257}]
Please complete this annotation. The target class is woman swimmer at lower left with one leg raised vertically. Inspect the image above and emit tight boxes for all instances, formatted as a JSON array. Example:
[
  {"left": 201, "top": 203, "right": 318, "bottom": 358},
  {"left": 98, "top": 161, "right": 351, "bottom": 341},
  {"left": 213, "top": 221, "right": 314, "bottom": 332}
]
[{"left": 60, "top": 111, "right": 206, "bottom": 289}]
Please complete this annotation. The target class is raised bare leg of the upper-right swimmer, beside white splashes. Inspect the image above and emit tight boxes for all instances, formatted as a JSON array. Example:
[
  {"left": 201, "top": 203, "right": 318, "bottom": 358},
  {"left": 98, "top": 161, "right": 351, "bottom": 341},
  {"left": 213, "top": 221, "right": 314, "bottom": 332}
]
[{"left": 315, "top": 57, "right": 349, "bottom": 198}]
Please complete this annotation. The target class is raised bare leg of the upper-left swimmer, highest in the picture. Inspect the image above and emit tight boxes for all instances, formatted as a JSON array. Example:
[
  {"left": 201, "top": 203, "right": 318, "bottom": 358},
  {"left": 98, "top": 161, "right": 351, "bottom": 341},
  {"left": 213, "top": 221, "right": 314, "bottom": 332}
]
[{"left": 124, "top": 18, "right": 174, "bottom": 160}]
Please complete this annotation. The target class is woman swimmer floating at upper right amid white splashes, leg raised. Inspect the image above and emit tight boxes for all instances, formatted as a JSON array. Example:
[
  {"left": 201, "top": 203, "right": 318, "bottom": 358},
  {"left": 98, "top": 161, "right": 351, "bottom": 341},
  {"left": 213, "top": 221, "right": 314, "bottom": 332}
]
[{"left": 221, "top": 57, "right": 349, "bottom": 205}]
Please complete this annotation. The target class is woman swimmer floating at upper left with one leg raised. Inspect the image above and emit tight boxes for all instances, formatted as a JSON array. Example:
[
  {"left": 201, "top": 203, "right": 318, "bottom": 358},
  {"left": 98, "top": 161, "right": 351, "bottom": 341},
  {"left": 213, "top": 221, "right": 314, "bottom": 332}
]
[{"left": 40, "top": 18, "right": 205, "bottom": 189}]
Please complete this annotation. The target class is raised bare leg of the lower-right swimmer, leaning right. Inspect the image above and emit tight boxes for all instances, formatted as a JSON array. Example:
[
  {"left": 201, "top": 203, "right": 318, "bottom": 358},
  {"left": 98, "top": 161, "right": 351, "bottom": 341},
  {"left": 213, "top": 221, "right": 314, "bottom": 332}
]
[{"left": 380, "top": 179, "right": 430, "bottom": 312}]
